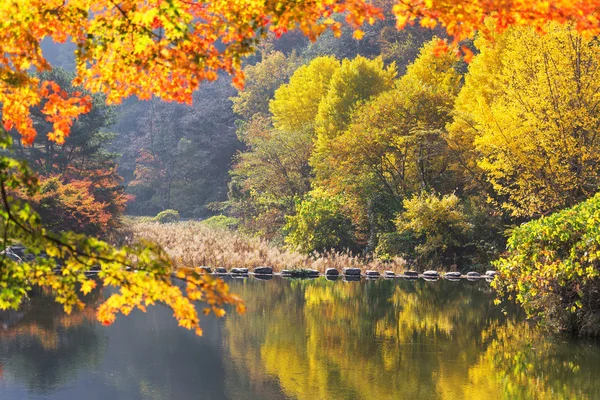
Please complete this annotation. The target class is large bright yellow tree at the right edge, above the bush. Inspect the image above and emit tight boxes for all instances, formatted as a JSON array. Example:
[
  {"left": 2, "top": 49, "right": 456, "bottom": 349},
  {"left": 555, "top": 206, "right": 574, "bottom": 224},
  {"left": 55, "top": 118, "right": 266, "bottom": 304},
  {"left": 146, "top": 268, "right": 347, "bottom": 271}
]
[{"left": 451, "top": 24, "right": 600, "bottom": 217}]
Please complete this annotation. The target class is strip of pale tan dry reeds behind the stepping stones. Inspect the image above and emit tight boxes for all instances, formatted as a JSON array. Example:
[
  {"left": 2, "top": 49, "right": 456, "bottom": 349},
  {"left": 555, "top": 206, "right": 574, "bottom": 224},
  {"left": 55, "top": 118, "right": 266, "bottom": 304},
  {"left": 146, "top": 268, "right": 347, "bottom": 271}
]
[{"left": 131, "top": 221, "right": 405, "bottom": 273}]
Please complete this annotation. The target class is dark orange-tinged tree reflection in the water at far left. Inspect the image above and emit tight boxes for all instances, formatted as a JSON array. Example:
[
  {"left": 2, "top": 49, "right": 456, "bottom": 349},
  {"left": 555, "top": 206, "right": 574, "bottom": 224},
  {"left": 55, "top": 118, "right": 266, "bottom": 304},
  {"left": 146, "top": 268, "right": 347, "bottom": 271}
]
[{"left": 0, "top": 291, "right": 106, "bottom": 395}]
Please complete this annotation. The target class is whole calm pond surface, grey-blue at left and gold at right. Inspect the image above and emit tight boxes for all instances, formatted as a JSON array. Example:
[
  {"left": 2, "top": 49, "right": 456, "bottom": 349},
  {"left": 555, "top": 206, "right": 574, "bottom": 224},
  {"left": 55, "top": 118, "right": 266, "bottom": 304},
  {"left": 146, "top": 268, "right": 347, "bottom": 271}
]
[{"left": 0, "top": 278, "right": 600, "bottom": 400}]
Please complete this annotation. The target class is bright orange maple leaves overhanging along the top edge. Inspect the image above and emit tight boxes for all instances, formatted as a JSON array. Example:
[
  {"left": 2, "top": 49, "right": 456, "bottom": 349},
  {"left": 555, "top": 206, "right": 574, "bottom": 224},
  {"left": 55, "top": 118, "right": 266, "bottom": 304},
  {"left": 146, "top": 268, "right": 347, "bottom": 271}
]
[{"left": 0, "top": 0, "right": 600, "bottom": 147}]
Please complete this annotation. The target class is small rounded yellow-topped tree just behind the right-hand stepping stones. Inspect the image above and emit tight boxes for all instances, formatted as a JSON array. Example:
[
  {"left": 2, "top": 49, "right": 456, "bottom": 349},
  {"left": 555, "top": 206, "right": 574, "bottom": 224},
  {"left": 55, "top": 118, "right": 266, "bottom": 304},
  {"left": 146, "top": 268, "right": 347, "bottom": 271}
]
[{"left": 396, "top": 193, "right": 472, "bottom": 266}]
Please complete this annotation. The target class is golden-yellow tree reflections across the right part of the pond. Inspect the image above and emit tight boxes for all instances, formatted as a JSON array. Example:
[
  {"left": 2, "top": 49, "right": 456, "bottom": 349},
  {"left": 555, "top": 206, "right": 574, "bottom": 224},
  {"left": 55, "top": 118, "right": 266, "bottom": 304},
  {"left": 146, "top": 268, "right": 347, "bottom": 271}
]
[{"left": 224, "top": 279, "right": 600, "bottom": 399}]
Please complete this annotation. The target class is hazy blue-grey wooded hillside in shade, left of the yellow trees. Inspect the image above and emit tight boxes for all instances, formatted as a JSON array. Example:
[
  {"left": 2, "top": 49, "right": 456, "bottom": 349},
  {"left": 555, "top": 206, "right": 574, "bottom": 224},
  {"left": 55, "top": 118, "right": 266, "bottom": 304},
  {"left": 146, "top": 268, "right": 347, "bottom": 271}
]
[{"left": 122, "top": 76, "right": 241, "bottom": 218}]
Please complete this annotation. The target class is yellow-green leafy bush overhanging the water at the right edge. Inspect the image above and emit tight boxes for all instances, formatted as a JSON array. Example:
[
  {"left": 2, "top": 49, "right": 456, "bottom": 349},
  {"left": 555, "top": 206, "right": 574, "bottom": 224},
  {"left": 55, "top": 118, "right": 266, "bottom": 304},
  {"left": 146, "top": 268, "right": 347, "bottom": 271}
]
[{"left": 493, "top": 193, "right": 600, "bottom": 336}]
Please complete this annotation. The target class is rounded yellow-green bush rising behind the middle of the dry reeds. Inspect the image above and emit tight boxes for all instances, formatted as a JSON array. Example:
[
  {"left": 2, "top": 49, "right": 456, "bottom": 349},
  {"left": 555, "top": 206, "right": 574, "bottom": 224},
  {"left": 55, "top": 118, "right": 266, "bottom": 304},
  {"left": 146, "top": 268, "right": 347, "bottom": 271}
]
[{"left": 284, "top": 191, "right": 354, "bottom": 253}]
